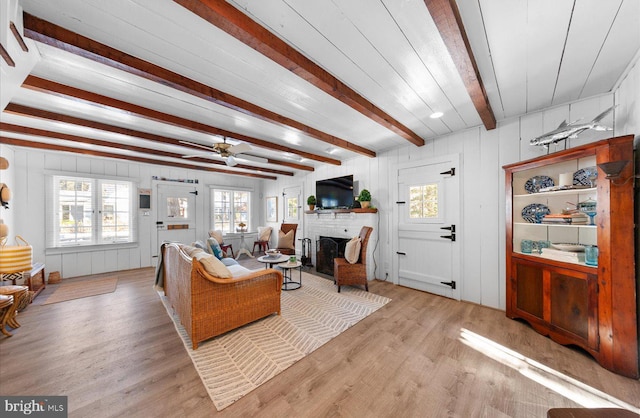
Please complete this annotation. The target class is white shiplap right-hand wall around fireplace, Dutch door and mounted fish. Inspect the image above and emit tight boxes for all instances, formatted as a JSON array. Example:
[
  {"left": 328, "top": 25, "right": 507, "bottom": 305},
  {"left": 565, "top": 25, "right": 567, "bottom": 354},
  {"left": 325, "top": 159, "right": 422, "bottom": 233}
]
[{"left": 264, "top": 55, "right": 640, "bottom": 309}]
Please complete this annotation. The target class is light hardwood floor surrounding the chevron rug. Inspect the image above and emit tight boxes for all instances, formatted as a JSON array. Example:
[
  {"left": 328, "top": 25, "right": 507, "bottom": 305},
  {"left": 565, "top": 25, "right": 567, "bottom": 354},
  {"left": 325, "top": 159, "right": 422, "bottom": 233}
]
[{"left": 0, "top": 269, "right": 640, "bottom": 418}]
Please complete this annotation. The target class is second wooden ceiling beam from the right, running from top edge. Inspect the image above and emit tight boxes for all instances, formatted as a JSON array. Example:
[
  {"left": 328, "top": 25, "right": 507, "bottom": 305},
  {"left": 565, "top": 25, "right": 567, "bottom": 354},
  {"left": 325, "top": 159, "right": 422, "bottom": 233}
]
[{"left": 174, "top": 0, "right": 424, "bottom": 146}]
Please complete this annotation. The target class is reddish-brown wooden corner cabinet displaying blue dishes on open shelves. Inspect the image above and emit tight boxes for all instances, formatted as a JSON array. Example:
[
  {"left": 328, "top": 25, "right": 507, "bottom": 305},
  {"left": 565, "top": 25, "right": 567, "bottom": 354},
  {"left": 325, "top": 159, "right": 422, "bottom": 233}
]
[{"left": 503, "top": 135, "right": 640, "bottom": 378}]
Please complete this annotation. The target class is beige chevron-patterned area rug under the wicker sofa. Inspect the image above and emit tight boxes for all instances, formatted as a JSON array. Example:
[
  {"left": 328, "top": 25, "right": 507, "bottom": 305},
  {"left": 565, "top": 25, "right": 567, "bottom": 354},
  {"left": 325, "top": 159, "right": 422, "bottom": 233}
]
[{"left": 159, "top": 272, "right": 391, "bottom": 411}]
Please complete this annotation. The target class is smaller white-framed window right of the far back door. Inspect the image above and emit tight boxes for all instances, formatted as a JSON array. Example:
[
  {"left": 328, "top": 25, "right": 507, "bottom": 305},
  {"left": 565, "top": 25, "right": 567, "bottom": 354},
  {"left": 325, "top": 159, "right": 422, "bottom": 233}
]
[{"left": 211, "top": 189, "right": 251, "bottom": 233}]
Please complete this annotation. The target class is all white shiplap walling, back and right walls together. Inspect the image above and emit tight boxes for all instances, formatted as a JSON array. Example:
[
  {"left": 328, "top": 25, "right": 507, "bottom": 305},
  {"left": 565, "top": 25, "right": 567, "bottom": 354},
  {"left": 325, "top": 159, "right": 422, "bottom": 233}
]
[{"left": 0, "top": 55, "right": 640, "bottom": 309}]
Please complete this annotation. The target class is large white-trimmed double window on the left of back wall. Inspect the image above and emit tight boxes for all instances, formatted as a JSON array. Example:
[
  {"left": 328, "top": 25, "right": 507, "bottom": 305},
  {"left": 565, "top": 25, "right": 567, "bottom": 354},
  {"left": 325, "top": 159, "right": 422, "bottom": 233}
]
[{"left": 47, "top": 175, "right": 137, "bottom": 248}]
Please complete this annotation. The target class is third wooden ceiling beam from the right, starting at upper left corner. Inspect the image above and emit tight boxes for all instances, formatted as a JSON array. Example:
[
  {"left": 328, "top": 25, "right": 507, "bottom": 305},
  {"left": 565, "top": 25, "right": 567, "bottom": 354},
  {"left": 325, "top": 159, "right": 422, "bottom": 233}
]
[{"left": 24, "top": 13, "right": 376, "bottom": 157}]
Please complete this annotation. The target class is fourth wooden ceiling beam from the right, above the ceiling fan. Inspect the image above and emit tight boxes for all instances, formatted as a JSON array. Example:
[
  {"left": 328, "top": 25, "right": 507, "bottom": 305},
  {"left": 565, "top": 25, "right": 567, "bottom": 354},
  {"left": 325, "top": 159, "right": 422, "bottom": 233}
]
[{"left": 22, "top": 75, "right": 341, "bottom": 165}]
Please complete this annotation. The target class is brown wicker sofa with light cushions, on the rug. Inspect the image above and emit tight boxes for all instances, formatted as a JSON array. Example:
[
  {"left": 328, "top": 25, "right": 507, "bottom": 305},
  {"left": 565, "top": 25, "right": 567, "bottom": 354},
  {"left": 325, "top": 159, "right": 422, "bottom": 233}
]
[{"left": 163, "top": 243, "right": 282, "bottom": 350}]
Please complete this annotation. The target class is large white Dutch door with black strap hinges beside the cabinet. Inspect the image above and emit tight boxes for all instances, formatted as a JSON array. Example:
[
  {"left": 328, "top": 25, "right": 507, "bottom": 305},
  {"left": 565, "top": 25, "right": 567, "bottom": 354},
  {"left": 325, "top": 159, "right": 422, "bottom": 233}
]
[{"left": 394, "top": 155, "right": 461, "bottom": 299}]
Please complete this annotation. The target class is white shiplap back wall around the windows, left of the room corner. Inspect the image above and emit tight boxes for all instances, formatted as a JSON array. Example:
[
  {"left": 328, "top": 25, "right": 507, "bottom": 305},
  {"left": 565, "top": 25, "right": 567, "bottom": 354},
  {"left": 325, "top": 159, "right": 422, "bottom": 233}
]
[{"left": 6, "top": 151, "right": 264, "bottom": 278}]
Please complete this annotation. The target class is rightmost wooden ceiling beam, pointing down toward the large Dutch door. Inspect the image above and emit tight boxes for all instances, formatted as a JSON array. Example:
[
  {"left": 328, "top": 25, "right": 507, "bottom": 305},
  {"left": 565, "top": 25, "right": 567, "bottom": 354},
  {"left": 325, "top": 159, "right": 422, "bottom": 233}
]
[{"left": 424, "top": 0, "right": 496, "bottom": 130}]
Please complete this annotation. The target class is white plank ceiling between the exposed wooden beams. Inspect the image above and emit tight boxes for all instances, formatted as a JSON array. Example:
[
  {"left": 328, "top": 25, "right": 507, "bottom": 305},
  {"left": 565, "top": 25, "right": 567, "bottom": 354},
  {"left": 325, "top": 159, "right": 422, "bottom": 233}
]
[{"left": 0, "top": 0, "right": 640, "bottom": 176}]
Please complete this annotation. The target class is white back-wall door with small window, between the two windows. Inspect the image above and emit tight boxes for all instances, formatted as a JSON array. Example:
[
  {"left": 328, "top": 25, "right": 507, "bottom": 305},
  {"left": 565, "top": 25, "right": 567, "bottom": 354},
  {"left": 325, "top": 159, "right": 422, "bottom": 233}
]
[{"left": 156, "top": 184, "right": 198, "bottom": 255}]
